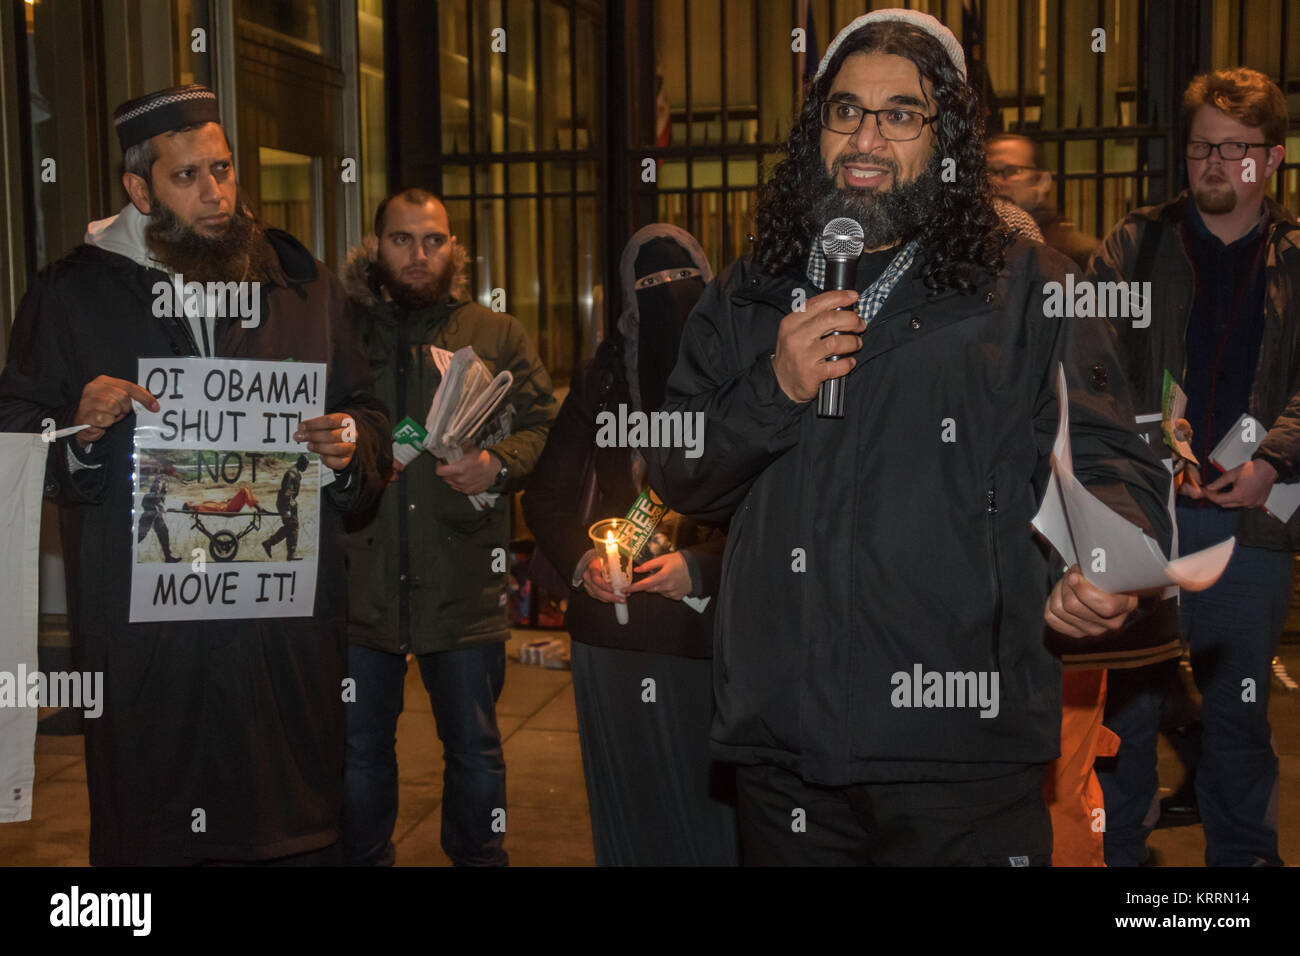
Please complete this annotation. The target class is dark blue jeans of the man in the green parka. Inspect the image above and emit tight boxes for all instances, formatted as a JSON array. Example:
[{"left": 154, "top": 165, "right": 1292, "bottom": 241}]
[{"left": 343, "top": 641, "right": 508, "bottom": 866}]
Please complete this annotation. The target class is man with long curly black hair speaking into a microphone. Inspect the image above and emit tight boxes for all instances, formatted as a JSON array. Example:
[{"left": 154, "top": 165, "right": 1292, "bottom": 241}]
[{"left": 650, "top": 10, "right": 1170, "bottom": 866}]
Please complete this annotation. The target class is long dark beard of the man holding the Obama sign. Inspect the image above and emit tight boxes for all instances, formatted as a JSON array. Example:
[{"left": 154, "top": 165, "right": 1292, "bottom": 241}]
[{"left": 144, "top": 191, "right": 276, "bottom": 282}]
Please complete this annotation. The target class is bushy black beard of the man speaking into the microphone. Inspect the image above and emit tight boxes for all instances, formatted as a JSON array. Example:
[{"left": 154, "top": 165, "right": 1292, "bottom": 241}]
[{"left": 809, "top": 153, "right": 940, "bottom": 248}]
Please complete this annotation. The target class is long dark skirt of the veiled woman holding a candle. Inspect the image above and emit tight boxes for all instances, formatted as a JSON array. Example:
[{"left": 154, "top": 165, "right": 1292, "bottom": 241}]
[{"left": 572, "top": 642, "right": 740, "bottom": 866}]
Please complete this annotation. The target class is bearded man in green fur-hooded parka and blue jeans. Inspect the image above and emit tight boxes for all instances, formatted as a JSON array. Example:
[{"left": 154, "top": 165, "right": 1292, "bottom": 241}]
[{"left": 343, "top": 189, "right": 556, "bottom": 866}]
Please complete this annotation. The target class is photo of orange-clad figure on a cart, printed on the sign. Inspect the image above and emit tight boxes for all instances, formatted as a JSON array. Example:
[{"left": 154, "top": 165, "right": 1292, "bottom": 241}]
[{"left": 135, "top": 449, "right": 320, "bottom": 564}]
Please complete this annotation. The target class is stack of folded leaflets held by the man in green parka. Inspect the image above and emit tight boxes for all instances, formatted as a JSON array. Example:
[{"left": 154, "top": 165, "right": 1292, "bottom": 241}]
[{"left": 393, "top": 345, "right": 515, "bottom": 511}]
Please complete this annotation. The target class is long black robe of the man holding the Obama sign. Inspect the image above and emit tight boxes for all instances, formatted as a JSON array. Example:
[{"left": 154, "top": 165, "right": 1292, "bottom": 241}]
[{"left": 0, "top": 230, "right": 389, "bottom": 865}]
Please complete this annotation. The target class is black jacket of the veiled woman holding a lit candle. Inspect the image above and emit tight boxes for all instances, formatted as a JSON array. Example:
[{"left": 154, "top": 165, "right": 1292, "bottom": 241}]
[{"left": 523, "top": 339, "right": 727, "bottom": 657}]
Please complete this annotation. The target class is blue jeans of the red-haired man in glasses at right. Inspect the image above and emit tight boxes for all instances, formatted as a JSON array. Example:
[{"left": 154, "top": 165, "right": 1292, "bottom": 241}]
[{"left": 1099, "top": 506, "right": 1292, "bottom": 866}]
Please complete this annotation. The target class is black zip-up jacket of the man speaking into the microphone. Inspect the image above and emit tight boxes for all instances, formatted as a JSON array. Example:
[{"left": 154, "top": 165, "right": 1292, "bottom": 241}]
[{"left": 651, "top": 241, "right": 1170, "bottom": 784}]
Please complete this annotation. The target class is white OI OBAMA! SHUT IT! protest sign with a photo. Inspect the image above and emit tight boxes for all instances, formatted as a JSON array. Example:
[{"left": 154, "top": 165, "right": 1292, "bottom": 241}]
[{"left": 131, "top": 358, "right": 325, "bottom": 622}]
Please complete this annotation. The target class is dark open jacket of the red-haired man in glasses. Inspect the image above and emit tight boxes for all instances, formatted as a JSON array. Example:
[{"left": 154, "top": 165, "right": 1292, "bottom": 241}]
[{"left": 1091, "top": 193, "right": 1300, "bottom": 550}]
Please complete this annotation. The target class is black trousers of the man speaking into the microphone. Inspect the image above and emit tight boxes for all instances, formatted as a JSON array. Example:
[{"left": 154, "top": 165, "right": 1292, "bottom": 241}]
[{"left": 736, "top": 765, "right": 1052, "bottom": 866}]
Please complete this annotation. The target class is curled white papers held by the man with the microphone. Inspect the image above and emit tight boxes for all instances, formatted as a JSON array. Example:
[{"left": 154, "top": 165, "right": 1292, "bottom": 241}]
[{"left": 1034, "top": 365, "right": 1236, "bottom": 594}]
